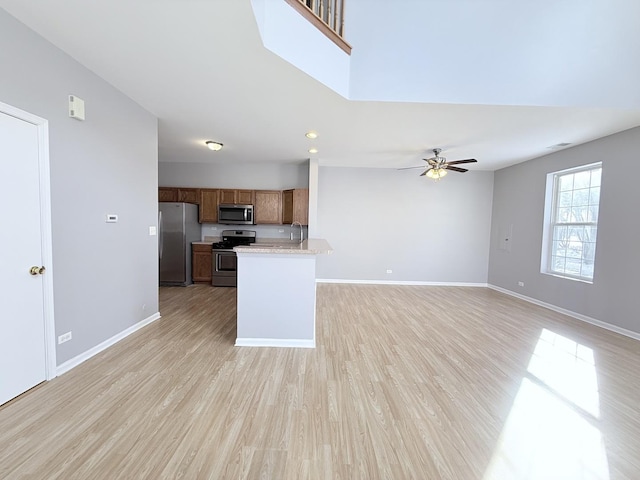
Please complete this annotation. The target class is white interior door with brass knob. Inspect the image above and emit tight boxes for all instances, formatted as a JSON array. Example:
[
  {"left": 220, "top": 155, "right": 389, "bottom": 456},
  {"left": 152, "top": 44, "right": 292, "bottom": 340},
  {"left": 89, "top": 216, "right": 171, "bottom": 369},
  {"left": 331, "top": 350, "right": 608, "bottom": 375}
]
[{"left": 0, "top": 111, "right": 49, "bottom": 405}]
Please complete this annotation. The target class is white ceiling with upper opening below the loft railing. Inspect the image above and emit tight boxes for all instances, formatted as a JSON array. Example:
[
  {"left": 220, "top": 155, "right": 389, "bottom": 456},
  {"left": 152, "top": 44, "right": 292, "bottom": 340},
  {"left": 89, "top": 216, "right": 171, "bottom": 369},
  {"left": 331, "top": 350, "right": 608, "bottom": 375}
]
[{"left": 0, "top": 0, "right": 640, "bottom": 170}]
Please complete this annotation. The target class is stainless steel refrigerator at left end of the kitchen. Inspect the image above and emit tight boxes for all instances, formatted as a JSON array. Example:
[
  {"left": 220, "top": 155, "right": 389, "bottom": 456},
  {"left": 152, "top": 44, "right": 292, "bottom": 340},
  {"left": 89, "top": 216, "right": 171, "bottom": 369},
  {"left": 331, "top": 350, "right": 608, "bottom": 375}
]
[{"left": 158, "top": 202, "right": 200, "bottom": 286}]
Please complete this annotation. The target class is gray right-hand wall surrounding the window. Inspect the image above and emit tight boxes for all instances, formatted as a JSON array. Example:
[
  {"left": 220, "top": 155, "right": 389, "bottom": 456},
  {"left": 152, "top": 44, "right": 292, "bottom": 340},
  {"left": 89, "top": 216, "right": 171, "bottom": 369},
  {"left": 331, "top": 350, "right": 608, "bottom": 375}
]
[{"left": 489, "top": 128, "right": 640, "bottom": 333}]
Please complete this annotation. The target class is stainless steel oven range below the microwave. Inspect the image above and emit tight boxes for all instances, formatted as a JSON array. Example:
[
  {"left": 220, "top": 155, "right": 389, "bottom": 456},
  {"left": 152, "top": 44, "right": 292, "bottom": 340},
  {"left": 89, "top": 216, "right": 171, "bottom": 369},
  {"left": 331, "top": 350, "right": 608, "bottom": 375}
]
[{"left": 211, "top": 230, "right": 256, "bottom": 287}]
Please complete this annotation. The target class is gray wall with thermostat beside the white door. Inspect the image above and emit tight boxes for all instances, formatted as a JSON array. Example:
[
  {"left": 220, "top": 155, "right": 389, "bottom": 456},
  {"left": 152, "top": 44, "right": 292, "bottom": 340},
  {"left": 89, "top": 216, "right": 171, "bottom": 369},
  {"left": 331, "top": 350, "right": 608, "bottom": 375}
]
[{"left": 0, "top": 9, "right": 158, "bottom": 364}]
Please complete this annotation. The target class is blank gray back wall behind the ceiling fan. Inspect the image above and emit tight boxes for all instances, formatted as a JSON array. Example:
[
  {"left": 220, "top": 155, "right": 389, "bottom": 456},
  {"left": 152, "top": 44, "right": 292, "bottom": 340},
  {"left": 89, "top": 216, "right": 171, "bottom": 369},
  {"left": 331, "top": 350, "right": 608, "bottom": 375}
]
[{"left": 317, "top": 167, "right": 493, "bottom": 283}]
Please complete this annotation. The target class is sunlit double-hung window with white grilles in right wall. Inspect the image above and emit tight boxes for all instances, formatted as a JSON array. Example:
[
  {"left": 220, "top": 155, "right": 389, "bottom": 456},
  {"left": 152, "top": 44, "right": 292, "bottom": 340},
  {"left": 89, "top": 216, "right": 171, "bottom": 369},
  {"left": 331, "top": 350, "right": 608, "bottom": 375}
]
[{"left": 542, "top": 163, "right": 602, "bottom": 282}]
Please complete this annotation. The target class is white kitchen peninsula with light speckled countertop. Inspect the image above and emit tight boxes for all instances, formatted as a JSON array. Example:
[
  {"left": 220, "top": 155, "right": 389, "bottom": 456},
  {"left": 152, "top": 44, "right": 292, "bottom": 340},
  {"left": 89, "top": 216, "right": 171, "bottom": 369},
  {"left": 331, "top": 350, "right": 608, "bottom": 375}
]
[{"left": 234, "top": 238, "right": 332, "bottom": 348}]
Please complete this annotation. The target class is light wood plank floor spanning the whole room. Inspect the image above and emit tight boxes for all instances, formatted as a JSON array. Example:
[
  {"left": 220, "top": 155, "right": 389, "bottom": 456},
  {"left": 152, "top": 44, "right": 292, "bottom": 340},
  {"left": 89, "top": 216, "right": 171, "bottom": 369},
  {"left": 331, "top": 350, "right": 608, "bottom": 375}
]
[{"left": 0, "top": 285, "right": 640, "bottom": 480}]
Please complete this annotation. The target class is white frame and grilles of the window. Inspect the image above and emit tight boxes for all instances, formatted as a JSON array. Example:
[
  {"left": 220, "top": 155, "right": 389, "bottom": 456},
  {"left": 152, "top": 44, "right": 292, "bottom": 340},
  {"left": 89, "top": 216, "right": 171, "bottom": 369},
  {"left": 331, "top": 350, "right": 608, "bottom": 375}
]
[{"left": 540, "top": 162, "right": 602, "bottom": 283}]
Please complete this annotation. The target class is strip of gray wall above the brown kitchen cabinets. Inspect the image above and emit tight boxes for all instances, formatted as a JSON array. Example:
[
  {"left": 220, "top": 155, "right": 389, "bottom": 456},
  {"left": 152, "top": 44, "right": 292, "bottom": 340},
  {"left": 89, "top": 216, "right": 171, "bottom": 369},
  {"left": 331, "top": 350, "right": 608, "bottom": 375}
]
[{"left": 158, "top": 162, "right": 309, "bottom": 190}]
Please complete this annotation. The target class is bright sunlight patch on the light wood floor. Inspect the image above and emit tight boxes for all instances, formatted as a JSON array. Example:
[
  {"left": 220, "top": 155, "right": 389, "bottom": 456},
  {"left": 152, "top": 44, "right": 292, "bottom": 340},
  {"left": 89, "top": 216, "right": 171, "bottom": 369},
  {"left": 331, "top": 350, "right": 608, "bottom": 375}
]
[{"left": 484, "top": 329, "right": 609, "bottom": 480}]
